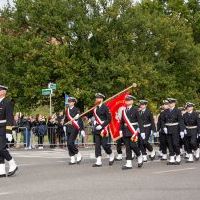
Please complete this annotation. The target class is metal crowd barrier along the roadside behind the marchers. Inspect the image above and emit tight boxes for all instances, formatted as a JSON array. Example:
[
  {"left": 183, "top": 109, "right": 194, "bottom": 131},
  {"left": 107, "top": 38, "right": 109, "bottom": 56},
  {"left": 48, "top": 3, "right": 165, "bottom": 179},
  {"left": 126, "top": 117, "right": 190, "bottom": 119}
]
[{"left": 8, "top": 126, "right": 158, "bottom": 149}]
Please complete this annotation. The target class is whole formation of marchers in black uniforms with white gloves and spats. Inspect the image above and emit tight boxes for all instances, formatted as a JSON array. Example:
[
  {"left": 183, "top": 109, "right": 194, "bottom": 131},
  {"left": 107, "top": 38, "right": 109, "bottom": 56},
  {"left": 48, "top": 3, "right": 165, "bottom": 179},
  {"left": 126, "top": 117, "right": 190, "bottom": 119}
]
[{"left": 0, "top": 85, "right": 200, "bottom": 178}]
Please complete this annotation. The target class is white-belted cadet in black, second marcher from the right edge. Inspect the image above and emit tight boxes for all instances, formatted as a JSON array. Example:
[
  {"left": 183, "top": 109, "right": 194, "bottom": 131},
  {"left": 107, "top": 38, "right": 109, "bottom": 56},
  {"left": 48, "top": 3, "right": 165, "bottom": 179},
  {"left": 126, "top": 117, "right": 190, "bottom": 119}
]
[{"left": 162, "top": 98, "right": 184, "bottom": 165}]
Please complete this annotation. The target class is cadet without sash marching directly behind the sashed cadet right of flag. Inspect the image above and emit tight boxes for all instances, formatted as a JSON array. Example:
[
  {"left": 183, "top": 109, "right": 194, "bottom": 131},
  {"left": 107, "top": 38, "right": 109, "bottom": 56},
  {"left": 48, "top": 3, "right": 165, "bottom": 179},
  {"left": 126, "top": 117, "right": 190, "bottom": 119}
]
[{"left": 139, "top": 100, "right": 156, "bottom": 162}]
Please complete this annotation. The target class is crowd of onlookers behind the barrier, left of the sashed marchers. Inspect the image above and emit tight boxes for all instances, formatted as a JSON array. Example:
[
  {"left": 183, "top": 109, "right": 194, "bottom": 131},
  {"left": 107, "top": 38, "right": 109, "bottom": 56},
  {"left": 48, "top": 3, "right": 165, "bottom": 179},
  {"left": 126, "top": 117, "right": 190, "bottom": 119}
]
[{"left": 11, "top": 112, "right": 69, "bottom": 149}]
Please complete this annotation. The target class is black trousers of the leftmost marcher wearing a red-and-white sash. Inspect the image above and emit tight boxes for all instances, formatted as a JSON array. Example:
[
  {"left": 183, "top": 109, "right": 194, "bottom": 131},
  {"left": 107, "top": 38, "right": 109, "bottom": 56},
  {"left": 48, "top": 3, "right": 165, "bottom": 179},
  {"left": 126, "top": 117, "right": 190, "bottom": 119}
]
[{"left": 66, "top": 125, "right": 79, "bottom": 156}]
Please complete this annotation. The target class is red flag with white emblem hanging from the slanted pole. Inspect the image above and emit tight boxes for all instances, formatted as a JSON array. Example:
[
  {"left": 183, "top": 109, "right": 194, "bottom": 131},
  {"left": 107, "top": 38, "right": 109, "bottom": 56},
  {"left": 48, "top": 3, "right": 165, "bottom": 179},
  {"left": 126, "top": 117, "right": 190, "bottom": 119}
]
[{"left": 106, "top": 92, "right": 129, "bottom": 141}]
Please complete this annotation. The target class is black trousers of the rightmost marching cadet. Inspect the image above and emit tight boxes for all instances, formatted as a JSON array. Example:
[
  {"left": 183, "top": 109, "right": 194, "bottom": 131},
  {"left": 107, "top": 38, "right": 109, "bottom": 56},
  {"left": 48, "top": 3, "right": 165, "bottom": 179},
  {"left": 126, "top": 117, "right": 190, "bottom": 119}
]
[{"left": 184, "top": 133, "right": 197, "bottom": 154}]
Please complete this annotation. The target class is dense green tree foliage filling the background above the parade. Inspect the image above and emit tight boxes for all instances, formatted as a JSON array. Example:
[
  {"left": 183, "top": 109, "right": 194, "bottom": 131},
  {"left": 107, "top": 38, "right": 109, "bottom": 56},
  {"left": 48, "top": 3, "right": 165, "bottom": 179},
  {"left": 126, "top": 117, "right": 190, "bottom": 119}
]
[{"left": 0, "top": 0, "right": 200, "bottom": 111}]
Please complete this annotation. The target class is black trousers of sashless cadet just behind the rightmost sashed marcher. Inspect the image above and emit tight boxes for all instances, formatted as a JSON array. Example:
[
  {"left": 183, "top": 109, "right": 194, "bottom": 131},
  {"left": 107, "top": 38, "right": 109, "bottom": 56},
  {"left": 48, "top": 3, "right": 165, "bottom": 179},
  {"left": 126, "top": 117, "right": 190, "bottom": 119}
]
[{"left": 139, "top": 127, "right": 153, "bottom": 155}]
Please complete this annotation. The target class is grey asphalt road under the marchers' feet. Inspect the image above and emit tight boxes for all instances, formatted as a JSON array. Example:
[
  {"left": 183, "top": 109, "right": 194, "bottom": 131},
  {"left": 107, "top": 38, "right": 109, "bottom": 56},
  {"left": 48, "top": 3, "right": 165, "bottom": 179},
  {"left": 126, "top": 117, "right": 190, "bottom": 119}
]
[{"left": 0, "top": 150, "right": 200, "bottom": 200}]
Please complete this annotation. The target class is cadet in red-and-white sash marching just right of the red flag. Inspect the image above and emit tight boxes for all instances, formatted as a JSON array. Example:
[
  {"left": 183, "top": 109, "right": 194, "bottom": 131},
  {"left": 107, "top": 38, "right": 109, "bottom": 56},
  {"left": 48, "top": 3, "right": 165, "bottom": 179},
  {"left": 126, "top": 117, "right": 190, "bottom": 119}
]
[{"left": 120, "top": 95, "right": 143, "bottom": 170}]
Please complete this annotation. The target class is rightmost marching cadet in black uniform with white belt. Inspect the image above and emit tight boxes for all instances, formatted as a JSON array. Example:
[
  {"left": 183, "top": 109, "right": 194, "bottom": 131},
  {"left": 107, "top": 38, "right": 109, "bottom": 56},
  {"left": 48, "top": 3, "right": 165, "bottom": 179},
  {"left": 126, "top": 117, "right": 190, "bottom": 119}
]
[{"left": 183, "top": 102, "right": 200, "bottom": 163}]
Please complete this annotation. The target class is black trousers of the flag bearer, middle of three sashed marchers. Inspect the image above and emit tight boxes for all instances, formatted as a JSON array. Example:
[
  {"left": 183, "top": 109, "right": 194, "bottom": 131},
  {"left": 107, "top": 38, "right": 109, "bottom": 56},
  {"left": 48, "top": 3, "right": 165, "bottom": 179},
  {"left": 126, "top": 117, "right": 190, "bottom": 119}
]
[{"left": 94, "top": 131, "right": 112, "bottom": 158}]
